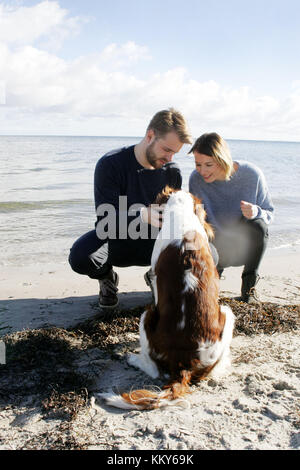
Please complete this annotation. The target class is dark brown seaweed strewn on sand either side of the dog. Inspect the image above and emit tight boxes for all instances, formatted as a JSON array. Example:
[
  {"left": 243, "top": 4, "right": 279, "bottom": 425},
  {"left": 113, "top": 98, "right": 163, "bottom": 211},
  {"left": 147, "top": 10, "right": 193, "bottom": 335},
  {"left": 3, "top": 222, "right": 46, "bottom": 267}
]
[{"left": 0, "top": 298, "right": 300, "bottom": 421}]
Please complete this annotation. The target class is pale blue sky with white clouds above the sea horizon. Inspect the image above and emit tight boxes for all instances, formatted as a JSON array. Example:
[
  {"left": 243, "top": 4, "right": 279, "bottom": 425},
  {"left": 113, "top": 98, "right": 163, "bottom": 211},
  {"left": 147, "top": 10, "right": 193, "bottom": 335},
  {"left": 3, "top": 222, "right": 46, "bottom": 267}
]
[{"left": 0, "top": 0, "right": 300, "bottom": 142}]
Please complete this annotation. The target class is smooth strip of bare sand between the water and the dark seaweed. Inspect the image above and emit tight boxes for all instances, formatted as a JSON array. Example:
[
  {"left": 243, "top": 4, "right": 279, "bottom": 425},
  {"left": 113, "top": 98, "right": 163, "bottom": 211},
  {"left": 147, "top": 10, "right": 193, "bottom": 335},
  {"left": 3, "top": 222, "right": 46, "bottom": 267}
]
[{"left": 0, "top": 247, "right": 300, "bottom": 337}]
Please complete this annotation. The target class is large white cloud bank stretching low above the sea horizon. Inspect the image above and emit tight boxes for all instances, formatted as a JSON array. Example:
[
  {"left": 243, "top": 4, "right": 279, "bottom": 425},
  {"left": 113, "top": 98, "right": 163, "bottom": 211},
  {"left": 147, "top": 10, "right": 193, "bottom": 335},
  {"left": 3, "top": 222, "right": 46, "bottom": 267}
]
[{"left": 0, "top": 1, "right": 300, "bottom": 140}]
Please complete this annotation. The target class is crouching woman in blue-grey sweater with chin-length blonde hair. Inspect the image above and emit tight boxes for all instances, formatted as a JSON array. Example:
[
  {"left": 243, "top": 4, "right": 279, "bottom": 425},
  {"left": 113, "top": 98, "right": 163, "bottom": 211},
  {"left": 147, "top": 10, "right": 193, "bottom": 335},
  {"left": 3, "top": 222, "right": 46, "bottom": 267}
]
[{"left": 189, "top": 133, "right": 274, "bottom": 303}]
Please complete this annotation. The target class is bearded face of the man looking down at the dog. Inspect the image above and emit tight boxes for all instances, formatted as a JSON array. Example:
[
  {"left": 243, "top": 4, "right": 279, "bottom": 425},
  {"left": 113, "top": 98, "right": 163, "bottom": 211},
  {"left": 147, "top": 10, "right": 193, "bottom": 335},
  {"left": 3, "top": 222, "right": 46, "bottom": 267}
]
[{"left": 146, "top": 129, "right": 183, "bottom": 169}]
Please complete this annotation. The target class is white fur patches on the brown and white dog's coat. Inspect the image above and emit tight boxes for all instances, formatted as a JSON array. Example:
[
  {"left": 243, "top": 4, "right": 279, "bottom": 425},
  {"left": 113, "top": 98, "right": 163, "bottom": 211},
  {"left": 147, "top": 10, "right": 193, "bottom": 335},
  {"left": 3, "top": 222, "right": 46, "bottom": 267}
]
[{"left": 100, "top": 191, "right": 235, "bottom": 409}]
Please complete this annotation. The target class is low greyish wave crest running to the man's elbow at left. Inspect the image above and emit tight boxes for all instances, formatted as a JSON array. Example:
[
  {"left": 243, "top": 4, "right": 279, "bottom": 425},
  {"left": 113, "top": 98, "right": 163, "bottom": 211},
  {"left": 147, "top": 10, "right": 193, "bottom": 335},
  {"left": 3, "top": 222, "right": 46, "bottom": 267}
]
[{"left": 0, "top": 199, "right": 93, "bottom": 213}]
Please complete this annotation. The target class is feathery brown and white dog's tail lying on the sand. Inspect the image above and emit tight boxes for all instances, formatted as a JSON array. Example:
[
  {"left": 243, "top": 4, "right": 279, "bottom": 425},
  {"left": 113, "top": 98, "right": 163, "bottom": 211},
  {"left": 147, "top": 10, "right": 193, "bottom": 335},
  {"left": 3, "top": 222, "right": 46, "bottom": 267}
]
[{"left": 98, "top": 370, "right": 209, "bottom": 410}]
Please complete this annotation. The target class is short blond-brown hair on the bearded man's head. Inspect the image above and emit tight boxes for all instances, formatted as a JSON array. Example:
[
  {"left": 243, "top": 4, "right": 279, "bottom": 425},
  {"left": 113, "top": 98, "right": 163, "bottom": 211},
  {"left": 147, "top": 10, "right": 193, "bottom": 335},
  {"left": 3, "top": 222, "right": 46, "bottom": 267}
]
[{"left": 147, "top": 108, "right": 192, "bottom": 144}]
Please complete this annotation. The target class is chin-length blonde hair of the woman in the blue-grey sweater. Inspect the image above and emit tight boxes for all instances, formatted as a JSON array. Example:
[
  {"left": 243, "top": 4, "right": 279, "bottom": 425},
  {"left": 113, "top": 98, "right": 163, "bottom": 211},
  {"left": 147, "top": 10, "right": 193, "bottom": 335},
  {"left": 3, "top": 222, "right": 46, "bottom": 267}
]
[{"left": 189, "top": 132, "right": 234, "bottom": 180}]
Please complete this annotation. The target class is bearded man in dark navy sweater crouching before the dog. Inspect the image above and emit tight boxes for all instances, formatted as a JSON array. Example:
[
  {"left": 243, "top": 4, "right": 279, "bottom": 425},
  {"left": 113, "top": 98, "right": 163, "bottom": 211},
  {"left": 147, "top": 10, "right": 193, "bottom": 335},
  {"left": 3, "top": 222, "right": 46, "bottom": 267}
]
[{"left": 69, "top": 108, "right": 192, "bottom": 309}]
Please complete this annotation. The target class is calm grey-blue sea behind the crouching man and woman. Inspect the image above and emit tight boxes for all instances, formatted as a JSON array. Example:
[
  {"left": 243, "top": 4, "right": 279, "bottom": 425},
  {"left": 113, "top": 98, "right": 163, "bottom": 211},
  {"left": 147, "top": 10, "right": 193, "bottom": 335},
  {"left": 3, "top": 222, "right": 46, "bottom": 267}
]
[{"left": 0, "top": 136, "right": 300, "bottom": 266}]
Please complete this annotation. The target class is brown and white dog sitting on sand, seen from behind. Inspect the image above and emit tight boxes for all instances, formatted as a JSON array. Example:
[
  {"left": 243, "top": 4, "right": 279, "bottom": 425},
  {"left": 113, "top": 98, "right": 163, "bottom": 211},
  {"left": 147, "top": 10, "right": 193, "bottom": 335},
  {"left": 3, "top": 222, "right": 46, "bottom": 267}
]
[{"left": 99, "top": 188, "right": 235, "bottom": 410}]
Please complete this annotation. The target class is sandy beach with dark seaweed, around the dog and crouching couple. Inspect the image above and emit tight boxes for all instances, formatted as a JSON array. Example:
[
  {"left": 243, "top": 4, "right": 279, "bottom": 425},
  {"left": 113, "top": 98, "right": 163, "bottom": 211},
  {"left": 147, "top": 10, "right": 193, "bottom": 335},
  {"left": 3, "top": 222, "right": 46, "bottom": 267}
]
[{"left": 0, "top": 244, "right": 300, "bottom": 452}]
